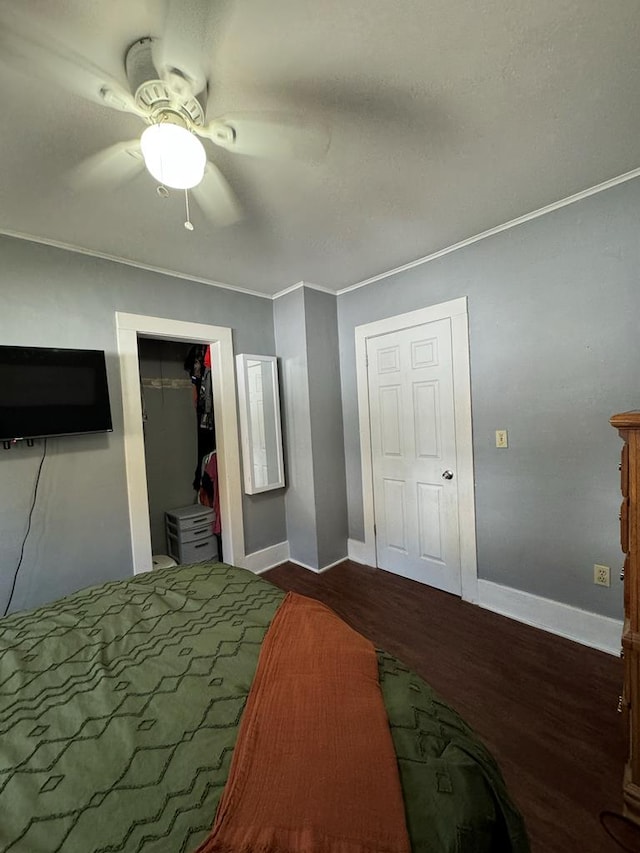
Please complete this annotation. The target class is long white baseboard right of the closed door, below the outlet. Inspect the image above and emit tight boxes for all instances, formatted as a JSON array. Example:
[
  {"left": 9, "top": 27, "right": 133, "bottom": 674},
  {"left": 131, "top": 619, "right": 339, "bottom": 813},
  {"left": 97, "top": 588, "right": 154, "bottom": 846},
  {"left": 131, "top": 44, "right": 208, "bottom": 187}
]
[{"left": 477, "top": 578, "right": 622, "bottom": 655}]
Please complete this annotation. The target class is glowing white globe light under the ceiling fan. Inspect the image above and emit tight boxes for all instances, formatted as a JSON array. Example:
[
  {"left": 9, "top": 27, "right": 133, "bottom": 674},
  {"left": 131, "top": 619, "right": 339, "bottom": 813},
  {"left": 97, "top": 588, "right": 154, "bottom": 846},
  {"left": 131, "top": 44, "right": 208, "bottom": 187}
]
[{"left": 140, "top": 122, "right": 207, "bottom": 190}]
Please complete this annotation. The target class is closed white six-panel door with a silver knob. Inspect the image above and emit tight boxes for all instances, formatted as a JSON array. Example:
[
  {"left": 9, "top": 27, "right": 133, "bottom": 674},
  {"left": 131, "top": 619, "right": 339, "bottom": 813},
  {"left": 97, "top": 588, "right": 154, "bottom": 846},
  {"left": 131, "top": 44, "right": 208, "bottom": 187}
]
[{"left": 367, "top": 319, "right": 461, "bottom": 594}]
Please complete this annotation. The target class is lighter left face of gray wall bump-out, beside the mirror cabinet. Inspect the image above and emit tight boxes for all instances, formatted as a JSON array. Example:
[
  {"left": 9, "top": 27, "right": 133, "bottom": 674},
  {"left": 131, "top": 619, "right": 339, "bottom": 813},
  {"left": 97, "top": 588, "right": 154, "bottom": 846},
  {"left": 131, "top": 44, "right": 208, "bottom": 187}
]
[{"left": 273, "top": 288, "right": 318, "bottom": 568}]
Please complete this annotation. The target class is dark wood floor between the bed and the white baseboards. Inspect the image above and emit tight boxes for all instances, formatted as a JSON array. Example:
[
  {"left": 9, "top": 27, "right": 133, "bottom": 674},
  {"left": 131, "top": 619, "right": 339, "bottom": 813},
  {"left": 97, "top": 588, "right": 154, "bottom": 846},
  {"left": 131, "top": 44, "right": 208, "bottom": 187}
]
[{"left": 264, "top": 561, "right": 640, "bottom": 853}]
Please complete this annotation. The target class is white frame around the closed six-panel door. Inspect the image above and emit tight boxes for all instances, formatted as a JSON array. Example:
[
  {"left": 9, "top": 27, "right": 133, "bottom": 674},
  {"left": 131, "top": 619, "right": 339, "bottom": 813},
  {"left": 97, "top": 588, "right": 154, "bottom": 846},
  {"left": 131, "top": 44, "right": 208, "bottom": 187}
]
[{"left": 355, "top": 296, "right": 478, "bottom": 602}]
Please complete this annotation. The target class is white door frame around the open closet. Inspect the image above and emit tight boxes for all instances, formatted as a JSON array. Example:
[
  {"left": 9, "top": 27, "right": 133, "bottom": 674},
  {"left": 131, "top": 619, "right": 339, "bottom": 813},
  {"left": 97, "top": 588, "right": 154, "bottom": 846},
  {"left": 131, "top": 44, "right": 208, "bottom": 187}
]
[{"left": 116, "top": 311, "right": 245, "bottom": 574}]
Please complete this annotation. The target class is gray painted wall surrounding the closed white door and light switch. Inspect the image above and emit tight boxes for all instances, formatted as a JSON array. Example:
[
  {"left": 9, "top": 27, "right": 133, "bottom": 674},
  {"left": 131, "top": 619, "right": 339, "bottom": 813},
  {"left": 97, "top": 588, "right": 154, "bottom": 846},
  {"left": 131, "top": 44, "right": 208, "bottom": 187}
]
[{"left": 338, "top": 180, "right": 640, "bottom": 618}]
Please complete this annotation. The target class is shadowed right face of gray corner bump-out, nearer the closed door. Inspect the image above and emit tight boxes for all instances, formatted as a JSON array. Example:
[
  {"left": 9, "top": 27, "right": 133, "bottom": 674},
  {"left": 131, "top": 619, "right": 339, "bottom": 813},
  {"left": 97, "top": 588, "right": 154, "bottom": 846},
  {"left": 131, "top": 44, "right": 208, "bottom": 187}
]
[{"left": 304, "top": 288, "right": 347, "bottom": 567}]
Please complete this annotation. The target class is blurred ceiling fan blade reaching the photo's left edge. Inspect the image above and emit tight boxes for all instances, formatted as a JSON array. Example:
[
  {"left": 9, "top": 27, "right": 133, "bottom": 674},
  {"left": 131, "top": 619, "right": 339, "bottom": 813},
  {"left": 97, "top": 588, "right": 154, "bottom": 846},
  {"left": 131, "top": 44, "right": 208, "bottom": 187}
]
[{"left": 0, "top": 8, "right": 142, "bottom": 115}]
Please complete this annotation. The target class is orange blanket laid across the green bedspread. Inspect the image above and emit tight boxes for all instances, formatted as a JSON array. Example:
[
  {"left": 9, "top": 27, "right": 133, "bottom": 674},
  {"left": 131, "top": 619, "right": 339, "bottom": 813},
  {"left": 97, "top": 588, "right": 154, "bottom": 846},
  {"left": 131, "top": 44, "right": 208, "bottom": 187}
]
[{"left": 197, "top": 593, "right": 411, "bottom": 853}]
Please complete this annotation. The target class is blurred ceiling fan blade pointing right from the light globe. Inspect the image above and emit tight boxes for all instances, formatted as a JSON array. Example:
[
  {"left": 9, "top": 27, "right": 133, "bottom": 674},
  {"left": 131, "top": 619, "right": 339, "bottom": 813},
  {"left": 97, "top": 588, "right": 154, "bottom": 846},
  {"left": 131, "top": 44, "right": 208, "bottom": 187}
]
[{"left": 195, "top": 113, "right": 331, "bottom": 160}]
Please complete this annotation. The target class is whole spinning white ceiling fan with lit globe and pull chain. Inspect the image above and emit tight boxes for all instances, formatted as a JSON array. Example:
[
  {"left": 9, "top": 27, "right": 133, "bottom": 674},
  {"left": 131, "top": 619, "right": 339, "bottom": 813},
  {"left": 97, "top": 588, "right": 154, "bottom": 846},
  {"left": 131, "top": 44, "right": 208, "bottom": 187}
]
[{"left": 0, "top": 0, "right": 330, "bottom": 230}]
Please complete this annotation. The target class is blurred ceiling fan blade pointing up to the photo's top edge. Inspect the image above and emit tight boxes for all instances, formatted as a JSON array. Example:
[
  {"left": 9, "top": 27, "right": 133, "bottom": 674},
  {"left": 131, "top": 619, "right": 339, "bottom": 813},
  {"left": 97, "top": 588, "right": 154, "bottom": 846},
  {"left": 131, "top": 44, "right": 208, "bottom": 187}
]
[{"left": 152, "top": 0, "right": 214, "bottom": 96}]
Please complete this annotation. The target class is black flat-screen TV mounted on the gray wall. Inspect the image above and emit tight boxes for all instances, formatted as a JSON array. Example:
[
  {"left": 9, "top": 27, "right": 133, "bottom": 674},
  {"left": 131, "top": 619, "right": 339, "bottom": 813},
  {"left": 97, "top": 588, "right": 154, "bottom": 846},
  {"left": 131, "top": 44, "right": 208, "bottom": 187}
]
[{"left": 0, "top": 346, "right": 112, "bottom": 441}]
